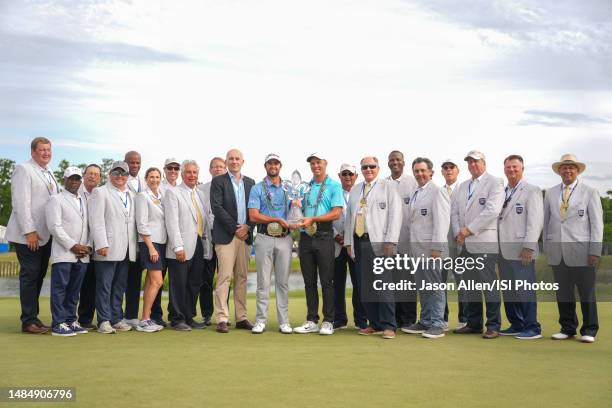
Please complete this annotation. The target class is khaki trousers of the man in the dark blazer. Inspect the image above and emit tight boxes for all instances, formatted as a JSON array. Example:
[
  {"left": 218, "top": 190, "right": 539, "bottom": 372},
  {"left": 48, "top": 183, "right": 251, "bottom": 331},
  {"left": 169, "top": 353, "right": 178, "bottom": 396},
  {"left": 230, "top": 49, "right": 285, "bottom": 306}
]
[{"left": 215, "top": 237, "right": 251, "bottom": 323}]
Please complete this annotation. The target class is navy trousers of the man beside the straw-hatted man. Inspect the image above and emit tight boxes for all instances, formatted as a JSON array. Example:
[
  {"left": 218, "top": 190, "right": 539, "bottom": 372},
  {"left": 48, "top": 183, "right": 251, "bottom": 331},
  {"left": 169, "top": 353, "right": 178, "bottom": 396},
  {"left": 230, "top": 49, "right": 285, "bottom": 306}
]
[{"left": 498, "top": 256, "right": 542, "bottom": 334}]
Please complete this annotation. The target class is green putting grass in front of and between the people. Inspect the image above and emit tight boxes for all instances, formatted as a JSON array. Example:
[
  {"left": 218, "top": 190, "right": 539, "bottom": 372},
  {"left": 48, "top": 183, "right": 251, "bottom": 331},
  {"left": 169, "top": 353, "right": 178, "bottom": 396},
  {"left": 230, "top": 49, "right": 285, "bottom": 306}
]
[{"left": 0, "top": 293, "right": 612, "bottom": 408}]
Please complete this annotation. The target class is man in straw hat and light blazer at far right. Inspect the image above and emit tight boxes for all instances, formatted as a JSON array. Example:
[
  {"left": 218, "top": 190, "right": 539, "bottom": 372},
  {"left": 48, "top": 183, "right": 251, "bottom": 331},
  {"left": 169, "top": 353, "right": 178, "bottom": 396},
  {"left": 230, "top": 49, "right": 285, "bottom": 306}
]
[{"left": 543, "top": 154, "right": 604, "bottom": 343}]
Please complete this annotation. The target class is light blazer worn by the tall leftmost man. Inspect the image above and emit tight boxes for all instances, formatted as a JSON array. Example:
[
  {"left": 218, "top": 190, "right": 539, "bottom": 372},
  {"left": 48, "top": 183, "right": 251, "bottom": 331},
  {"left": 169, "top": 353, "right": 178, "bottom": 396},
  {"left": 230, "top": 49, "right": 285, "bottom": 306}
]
[{"left": 5, "top": 160, "right": 60, "bottom": 245}]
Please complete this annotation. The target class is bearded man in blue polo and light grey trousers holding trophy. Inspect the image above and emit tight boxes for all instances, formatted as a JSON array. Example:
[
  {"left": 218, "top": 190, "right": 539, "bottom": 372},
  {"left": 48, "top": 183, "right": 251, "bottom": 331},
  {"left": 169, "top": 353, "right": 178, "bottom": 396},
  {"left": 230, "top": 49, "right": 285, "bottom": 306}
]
[{"left": 248, "top": 153, "right": 293, "bottom": 334}]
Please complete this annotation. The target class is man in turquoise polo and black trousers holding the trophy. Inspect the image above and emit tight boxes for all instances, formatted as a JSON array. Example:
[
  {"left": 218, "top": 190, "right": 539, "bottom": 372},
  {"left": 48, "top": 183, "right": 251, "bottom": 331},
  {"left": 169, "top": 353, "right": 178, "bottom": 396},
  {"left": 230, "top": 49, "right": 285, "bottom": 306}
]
[{"left": 289, "top": 153, "right": 344, "bottom": 335}]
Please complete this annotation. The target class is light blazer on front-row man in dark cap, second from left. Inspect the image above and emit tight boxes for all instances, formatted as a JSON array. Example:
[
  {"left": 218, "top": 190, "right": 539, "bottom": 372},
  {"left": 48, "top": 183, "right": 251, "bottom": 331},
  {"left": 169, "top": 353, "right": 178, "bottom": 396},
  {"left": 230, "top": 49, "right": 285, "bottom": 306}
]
[{"left": 45, "top": 190, "right": 91, "bottom": 264}]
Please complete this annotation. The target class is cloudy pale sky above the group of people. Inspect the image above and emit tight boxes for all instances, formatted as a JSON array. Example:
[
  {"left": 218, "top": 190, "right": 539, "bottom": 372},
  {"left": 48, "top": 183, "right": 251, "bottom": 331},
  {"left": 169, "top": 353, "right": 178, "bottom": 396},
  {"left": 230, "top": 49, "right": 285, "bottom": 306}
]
[{"left": 0, "top": 0, "right": 612, "bottom": 192}]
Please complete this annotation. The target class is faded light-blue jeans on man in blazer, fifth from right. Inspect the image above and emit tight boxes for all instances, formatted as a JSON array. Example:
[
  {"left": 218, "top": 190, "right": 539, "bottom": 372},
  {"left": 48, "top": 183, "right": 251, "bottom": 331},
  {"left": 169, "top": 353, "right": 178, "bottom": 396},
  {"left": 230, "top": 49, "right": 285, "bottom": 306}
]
[{"left": 416, "top": 268, "right": 446, "bottom": 329}]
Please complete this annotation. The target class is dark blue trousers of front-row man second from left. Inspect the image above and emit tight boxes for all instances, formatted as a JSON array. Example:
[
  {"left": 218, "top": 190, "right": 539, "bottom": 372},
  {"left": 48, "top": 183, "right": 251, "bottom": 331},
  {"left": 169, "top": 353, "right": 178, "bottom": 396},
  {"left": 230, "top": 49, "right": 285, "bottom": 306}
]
[{"left": 51, "top": 261, "right": 87, "bottom": 327}]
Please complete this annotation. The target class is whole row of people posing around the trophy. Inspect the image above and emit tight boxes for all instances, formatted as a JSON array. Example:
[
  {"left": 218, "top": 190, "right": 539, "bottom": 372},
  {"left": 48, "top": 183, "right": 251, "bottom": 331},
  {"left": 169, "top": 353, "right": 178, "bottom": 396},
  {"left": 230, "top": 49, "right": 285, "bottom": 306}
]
[{"left": 6, "top": 137, "right": 603, "bottom": 343}]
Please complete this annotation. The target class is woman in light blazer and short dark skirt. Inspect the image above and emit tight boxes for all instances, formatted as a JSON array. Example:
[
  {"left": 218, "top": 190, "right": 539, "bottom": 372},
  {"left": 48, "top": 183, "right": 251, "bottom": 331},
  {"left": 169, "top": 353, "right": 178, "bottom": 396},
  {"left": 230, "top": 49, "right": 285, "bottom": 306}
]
[{"left": 136, "top": 167, "right": 167, "bottom": 333}]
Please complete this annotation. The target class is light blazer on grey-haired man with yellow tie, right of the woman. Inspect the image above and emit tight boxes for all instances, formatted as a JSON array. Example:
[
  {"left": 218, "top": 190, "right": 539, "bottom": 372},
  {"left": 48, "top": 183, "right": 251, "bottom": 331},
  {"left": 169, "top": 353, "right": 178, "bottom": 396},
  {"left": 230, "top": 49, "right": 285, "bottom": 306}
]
[{"left": 162, "top": 184, "right": 212, "bottom": 260}]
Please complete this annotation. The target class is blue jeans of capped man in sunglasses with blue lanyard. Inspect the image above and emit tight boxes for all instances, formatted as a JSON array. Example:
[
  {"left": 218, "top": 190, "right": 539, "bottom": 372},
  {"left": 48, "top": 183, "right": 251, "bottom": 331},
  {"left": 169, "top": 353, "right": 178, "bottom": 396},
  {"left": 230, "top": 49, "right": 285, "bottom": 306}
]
[{"left": 95, "top": 257, "right": 130, "bottom": 324}]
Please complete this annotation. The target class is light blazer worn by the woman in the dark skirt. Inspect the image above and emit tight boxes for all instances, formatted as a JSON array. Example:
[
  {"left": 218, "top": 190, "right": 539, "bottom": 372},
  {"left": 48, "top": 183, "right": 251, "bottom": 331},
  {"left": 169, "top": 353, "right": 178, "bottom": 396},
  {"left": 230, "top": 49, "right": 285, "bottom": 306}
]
[{"left": 134, "top": 188, "right": 168, "bottom": 244}]
